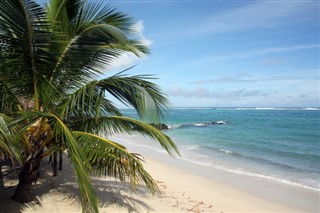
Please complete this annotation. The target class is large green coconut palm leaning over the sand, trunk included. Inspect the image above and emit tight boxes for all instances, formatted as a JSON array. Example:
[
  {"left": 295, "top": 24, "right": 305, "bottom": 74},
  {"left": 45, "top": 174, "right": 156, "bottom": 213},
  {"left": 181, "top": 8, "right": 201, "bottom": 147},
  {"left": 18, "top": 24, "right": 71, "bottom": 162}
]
[{"left": 0, "top": 0, "right": 178, "bottom": 212}]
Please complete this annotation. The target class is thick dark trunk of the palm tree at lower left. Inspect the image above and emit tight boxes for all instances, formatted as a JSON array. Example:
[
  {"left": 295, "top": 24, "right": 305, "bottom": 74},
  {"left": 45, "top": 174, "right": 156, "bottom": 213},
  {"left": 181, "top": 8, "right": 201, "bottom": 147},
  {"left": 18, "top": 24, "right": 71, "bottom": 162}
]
[{"left": 12, "top": 149, "right": 43, "bottom": 203}]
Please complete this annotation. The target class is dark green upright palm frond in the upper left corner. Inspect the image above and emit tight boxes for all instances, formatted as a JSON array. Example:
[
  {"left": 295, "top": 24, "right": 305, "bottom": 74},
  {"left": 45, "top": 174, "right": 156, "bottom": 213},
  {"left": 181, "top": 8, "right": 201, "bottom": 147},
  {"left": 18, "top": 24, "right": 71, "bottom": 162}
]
[{"left": 0, "top": 0, "right": 51, "bottom": 105}]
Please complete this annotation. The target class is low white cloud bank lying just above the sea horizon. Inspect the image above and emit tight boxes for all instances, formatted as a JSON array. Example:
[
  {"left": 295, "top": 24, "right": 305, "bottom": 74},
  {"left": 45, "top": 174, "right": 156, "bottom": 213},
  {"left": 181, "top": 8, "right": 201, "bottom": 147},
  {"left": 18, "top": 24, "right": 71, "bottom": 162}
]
[{"left": 166, "top": 87, "right": 320, "bottom": 107}]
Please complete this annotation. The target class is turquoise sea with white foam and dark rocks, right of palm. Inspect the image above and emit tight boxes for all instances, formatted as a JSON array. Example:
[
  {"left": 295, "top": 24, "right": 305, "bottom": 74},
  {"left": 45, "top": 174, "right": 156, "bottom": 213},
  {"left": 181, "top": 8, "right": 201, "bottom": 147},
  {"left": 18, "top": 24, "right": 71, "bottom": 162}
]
[{"left": 120, "top": 108, "right": 320, "bottom": 191}]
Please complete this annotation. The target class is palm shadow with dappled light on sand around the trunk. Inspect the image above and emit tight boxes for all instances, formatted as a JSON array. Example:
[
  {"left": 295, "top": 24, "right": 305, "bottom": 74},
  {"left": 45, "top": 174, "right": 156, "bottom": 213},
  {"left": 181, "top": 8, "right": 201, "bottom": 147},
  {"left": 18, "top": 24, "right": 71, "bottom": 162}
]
[{"left": 0, "top": 161, "right": 153, "bottom": 213}]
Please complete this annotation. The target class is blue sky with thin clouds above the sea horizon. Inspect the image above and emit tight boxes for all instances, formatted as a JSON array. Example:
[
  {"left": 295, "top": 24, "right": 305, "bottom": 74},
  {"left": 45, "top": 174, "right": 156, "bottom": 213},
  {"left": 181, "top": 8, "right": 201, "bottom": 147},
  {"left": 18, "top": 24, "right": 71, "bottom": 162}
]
[{"left": 108, "top": 0, "right": 320, "bottom": 107}]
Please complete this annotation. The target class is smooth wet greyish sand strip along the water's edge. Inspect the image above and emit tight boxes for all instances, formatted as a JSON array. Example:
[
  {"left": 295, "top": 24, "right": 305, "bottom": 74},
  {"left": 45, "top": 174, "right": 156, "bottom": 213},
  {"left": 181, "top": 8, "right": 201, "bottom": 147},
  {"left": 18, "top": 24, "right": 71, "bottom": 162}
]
[{"left": 114, "top": 135, "right": 320, "bottom": 212}]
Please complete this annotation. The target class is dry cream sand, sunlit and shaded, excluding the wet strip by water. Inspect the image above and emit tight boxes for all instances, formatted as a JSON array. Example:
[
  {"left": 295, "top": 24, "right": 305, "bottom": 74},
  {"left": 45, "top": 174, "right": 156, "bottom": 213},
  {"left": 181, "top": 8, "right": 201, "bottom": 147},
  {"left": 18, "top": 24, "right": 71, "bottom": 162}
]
[{"left": 0, "top": 156, "right": 316, "bottom": 213}]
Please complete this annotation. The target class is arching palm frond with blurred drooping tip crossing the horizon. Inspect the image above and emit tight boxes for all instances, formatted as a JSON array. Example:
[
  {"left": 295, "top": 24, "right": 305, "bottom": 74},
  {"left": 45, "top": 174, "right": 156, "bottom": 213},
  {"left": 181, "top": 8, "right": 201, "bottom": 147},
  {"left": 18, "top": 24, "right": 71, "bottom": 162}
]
[{"left": 59, "top": 73, "right": 167, "bottom": 122}]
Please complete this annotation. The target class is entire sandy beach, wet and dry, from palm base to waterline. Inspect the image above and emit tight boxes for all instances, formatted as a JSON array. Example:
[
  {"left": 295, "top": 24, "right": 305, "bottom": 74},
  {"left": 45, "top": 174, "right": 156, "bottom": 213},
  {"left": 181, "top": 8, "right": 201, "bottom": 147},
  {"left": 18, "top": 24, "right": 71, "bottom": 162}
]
[{"left": 0, "top": 132, "right": 319, "bottom": 213}]
